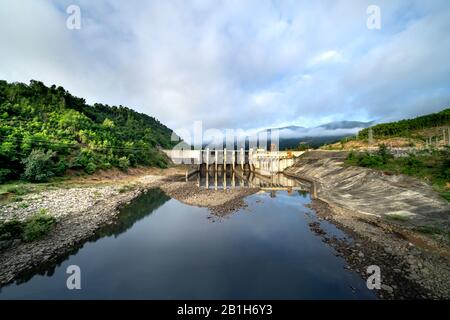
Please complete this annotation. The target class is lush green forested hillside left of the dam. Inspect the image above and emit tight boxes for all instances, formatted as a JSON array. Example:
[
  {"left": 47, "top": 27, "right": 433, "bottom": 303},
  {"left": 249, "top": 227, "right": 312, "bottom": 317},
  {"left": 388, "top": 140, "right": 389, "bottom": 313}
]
[{"left": 0, "top": 80, "right": 173, "bottom": 182}]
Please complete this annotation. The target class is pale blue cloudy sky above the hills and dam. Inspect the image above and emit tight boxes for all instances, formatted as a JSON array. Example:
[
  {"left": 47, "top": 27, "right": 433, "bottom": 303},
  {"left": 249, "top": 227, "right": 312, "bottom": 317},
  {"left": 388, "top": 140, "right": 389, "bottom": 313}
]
[{"left": 0, "top": 0, "right": 450, "bottom": 136}]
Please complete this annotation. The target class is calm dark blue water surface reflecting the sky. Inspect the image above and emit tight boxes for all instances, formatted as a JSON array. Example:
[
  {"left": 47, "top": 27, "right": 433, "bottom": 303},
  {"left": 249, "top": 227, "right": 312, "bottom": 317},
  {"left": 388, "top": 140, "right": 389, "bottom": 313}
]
[{"left": 0, "top": 189, "right": 375, "bottom": 299}]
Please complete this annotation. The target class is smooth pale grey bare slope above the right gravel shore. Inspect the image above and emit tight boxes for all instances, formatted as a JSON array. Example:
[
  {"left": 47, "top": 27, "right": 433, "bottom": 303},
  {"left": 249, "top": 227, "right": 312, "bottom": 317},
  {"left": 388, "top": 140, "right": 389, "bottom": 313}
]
[{"left": 286, "top": 152, "right": 450, "bottom": 228}]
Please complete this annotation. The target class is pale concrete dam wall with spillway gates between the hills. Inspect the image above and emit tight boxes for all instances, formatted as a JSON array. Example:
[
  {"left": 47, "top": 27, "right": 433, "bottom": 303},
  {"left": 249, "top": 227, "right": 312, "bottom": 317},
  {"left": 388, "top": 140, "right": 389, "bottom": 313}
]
[{"left": 164, "top": 148, "right": 304, "bottom": 175}]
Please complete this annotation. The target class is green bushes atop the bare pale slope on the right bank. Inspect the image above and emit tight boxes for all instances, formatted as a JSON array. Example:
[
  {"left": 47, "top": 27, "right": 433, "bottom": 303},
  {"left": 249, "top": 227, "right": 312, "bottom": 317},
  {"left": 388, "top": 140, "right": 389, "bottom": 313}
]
[{"left": 346, "top": 145, "right": 450, "bottom": 201}]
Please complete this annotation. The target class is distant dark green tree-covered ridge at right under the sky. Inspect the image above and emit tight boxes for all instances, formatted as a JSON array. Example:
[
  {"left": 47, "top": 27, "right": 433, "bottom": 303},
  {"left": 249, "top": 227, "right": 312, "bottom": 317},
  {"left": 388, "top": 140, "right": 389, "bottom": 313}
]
[{"left": 358, "top": 108, "right": 450, "bottom": 139}]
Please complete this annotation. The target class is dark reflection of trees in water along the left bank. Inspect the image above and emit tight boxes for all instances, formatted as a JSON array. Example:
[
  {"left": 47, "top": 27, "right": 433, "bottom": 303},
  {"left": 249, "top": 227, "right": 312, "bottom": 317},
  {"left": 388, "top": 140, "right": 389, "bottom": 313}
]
[{"left": 6, "top": 189, "right": 170, "bottom": 284}]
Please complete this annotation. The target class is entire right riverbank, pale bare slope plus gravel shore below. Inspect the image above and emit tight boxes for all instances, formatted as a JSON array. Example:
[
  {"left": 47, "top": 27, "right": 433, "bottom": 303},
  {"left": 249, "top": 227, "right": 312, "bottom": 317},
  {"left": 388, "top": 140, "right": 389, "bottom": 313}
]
[{"left": 287, "top": 154, "right": 450, "bottom": 299}]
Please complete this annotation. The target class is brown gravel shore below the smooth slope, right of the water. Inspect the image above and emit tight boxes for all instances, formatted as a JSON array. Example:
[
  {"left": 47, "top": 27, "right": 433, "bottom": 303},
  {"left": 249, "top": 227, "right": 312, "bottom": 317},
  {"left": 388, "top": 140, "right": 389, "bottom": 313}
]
[{"left": 311, "top": 199, "right": 450, "bottom": 300}]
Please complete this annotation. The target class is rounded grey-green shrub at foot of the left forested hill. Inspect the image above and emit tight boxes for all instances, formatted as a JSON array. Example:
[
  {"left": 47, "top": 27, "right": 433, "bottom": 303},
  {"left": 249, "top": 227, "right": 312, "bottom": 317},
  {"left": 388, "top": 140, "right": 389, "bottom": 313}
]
[{"left": 22, "top": 149, "right": 56, "bottom": 182}]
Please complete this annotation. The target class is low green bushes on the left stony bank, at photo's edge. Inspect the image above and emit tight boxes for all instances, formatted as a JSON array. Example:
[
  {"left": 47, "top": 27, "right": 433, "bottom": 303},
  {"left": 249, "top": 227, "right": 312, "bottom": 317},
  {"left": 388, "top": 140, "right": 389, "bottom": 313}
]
[{"left": 0, "top": 209, "right": 56, "bottom": 242}]
